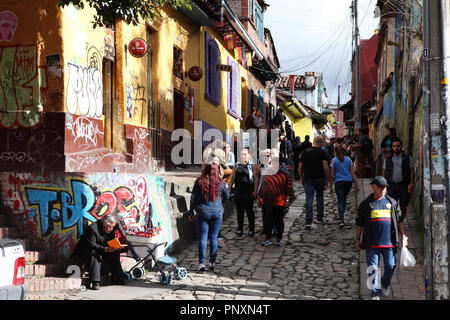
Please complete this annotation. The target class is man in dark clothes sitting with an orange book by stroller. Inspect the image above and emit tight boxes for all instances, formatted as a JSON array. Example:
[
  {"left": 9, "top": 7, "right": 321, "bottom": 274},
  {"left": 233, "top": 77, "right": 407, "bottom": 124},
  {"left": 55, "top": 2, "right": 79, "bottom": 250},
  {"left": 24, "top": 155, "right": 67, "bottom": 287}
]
[{"left": 74, "top": 214, "right": 130, "bottom": 290}]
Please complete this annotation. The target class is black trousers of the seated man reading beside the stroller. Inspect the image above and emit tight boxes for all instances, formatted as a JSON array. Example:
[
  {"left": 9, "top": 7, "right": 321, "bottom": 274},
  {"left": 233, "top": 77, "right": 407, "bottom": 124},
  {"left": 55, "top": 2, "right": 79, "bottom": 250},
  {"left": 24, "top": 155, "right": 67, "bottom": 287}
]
[{"left": 85, "top": 250, "right": 123, "bottom": 282}]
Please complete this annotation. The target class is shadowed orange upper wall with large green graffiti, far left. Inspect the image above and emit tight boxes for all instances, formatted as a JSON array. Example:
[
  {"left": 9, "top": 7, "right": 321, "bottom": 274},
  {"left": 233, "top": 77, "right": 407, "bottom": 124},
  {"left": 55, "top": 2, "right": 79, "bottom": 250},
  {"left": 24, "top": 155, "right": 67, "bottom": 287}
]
[{"left": 0, "top": 0, "right": 63, "bottom": 128}]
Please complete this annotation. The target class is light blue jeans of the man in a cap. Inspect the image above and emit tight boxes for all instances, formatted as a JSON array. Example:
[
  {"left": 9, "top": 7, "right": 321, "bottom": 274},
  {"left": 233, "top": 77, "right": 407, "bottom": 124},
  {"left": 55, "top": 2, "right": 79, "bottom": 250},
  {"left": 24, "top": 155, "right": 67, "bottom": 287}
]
[{"left": 366, "top": 248, "right": 395, "bottom": 296}]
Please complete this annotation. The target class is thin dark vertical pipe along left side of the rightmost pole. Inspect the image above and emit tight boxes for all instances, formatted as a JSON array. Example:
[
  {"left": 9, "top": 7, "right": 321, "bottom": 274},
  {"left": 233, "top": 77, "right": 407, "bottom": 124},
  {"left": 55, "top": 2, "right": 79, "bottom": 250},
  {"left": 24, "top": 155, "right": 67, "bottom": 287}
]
[{"left": 423, "top": 0, "right": 433, "bottom": 300}]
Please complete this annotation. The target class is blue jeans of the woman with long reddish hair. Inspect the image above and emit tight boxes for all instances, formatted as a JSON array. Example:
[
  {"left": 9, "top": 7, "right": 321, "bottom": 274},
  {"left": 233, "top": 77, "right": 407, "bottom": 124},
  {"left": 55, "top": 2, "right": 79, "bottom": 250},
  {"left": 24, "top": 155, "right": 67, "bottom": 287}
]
[{"left": 196, "top": 211, "right": 223, "bottom": 263}]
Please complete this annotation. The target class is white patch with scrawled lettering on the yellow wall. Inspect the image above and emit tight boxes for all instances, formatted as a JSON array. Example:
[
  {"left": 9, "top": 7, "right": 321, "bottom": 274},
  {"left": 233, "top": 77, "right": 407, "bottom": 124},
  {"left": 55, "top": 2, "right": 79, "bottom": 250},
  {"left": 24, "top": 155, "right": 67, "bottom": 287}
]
[{"left": 66, "top": 63, "right": 103, "bottom": 118}]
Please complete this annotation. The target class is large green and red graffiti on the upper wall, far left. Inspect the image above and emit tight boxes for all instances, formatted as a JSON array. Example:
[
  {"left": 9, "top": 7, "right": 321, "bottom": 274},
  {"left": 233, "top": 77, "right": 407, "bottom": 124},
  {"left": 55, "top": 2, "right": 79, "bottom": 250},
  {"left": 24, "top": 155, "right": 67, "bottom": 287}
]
[{"left": 0, "top": 45, "right": 47, "bottom": 129}]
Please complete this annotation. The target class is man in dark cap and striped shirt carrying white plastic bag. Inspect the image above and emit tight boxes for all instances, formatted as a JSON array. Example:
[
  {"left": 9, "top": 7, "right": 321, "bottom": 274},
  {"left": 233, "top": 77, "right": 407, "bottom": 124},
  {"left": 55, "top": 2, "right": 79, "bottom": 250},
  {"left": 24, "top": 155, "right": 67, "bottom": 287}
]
[{"left": 355, "top": 176, "right": 408, "bottom": 300}]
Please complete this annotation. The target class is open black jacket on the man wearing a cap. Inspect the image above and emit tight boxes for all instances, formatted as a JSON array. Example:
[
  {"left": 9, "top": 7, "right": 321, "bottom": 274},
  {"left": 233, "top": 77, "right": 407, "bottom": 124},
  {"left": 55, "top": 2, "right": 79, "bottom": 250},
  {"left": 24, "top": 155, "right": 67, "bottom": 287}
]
[{"left": 356, "top": 193, "right": 403, "bottom": 253}]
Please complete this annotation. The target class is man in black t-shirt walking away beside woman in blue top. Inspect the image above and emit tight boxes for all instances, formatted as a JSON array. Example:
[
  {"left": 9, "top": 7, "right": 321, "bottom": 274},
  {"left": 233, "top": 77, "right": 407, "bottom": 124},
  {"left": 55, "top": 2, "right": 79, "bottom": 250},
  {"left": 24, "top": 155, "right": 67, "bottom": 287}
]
[{"left": 298, "top": 136, "right": 329, "bottom": 230}]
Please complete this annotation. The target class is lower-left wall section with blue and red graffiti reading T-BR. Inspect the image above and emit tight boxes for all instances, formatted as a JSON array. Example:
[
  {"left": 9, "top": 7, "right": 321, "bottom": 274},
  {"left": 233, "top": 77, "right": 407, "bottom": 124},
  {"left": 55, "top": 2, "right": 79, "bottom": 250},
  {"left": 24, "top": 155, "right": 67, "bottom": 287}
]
[{"left": 0, "top": 173, "right": 172, "bottom": 257}]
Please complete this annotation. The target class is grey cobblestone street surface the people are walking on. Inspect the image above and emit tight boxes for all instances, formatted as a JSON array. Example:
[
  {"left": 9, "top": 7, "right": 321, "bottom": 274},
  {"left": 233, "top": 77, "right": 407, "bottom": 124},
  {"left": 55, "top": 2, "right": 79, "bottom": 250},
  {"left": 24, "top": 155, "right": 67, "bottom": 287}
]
[{"left": 69, "top": 181, "right": 360, "bottom": 300}]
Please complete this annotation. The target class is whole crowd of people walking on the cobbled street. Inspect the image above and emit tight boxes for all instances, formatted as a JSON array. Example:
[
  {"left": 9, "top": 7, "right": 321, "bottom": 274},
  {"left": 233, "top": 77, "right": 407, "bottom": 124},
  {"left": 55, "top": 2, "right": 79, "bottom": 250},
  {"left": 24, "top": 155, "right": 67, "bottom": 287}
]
[{"left": 187, "top": 117, "right": 414, "bottom": 299}]
